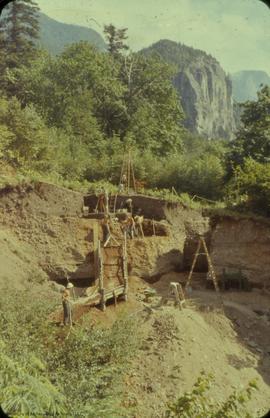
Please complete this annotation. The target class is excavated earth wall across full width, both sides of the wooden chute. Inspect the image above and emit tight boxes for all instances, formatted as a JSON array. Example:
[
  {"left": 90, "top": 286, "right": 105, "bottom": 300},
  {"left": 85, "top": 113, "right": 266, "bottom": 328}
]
[{"left": 0, "top": 183, "right": 270, "bottom": 291}]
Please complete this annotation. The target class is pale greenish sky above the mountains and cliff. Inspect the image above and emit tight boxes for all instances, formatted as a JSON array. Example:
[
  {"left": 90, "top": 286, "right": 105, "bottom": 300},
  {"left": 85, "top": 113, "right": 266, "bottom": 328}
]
[{"left": 36, "top": 0, "right": 270, "bottom": 75}]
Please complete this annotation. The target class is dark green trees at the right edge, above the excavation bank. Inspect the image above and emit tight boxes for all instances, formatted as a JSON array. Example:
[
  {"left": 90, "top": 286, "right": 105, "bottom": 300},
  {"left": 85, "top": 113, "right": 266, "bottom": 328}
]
[{"left": 226, "top": 86, "right": 270, "bottom": 216}]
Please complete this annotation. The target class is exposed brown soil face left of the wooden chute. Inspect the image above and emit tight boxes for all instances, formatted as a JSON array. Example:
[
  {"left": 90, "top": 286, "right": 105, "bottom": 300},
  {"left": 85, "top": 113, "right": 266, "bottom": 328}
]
[{"left": 0, "top": 183, "right": 93, "bottom": 286}]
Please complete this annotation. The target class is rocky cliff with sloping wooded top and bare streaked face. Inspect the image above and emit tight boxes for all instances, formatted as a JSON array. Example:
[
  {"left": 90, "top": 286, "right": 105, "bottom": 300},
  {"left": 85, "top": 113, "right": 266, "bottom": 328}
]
[{"left": 143, "top": 40, "right": 235, "bottom": 139}]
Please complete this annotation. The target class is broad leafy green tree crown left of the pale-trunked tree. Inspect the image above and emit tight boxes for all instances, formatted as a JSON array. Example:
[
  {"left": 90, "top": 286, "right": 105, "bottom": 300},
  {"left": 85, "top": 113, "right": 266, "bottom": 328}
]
[{"left": 15, "top": 42, "right": 124, "bottom": 137}]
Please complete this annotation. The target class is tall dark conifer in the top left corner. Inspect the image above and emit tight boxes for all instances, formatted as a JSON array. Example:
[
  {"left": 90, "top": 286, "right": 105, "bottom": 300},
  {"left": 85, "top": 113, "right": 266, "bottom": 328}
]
[{"left": 1, "top": 0, "right": 39, "bottom": 68}]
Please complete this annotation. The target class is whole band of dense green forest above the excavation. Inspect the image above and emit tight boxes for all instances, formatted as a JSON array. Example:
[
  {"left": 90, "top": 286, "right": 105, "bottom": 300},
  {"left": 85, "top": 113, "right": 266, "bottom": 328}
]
[{"left": 0, "top": 0, "right": 270, "bottom": 214}]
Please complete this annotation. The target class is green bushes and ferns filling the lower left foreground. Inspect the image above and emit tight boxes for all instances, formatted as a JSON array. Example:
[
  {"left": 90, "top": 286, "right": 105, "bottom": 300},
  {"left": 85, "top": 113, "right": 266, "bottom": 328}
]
[{"left": 0, "top": 287, "right": 141, "bottom": 418}]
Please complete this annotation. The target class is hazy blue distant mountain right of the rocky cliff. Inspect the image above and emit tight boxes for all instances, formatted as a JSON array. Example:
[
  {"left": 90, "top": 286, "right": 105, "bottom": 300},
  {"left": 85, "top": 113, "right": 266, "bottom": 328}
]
[{"left": 231, "top": 71, "right": 270, "bottom": 102}]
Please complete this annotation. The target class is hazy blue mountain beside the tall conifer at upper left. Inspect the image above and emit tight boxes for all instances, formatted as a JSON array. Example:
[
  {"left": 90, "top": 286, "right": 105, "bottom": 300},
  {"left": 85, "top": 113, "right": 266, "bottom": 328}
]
[{"left": 39, "top": 13, "right": 106, "bottom": 55}]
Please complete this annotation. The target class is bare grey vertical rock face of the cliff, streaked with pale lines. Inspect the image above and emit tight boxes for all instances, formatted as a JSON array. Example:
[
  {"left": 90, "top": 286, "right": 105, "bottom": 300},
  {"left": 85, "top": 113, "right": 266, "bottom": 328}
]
[{"left": 175, "top": 60, "right": 235, "bottom": 139}]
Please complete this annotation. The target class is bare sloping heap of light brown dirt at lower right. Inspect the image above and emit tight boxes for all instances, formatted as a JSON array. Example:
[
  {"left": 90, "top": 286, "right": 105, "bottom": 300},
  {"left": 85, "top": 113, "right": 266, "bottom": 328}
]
[{"left": 122, "top": 284, "right": 270, "bottom": 418}]
